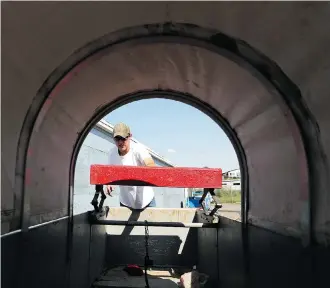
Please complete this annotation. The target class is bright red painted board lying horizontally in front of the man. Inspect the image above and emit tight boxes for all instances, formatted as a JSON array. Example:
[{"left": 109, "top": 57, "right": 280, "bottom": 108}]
[{"left": 90, "top": 165, "right": 222, "bottom": 188}]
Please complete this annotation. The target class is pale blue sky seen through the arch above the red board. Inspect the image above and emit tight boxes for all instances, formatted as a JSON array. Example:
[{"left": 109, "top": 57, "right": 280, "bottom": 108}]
[{"left": 104, "top": 99, "right": 239, "bottom": 171}]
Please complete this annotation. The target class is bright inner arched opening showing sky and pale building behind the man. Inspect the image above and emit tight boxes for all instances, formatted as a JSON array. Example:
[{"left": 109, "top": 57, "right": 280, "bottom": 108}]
[{"left": 73, "top": 97, "right": 242, "bottom": 220}]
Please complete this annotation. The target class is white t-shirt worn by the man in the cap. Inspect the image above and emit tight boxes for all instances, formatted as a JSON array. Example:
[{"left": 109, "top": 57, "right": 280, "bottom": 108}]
[{"left": 109, "top": 142, "right": 154, "bottom": 209}]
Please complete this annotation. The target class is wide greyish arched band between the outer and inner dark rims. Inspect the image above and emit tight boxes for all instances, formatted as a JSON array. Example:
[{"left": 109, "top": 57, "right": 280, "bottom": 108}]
[{"left": 9, "top": 25, "right": 312, "bottom": 243}]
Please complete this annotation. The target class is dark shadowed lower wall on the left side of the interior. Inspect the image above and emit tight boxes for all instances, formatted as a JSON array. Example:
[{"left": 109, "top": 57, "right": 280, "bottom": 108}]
[{"left": 1, "top": 213, "right": 106, "bottom": 288}]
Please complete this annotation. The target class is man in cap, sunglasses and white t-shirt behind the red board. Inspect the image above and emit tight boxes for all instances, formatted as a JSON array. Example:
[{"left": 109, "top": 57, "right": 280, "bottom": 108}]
[{"left": 107, "top": 123, "right": 156, "bottom": 210}]
